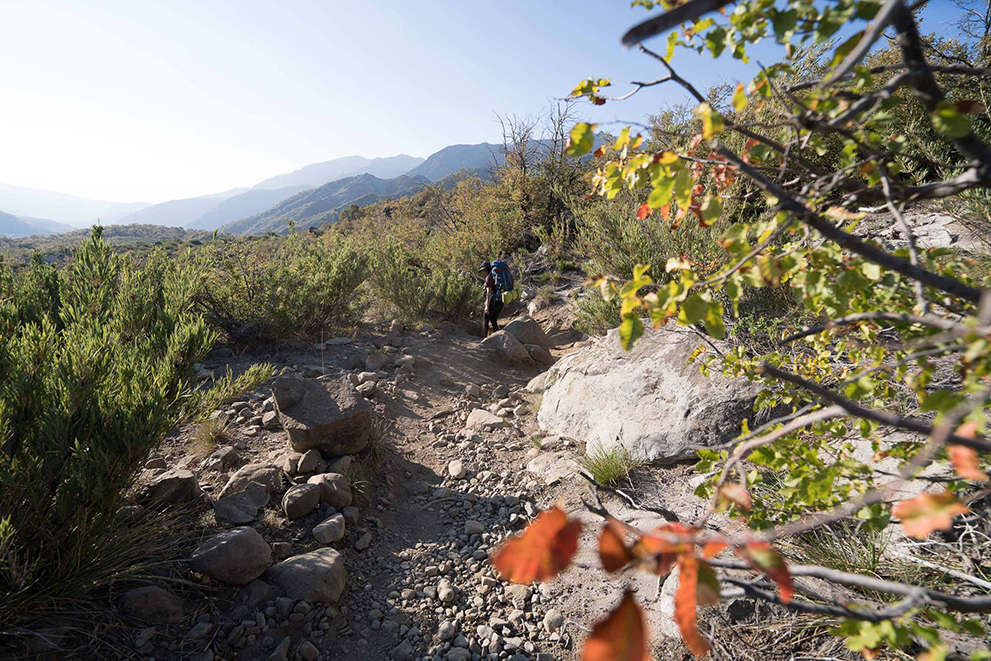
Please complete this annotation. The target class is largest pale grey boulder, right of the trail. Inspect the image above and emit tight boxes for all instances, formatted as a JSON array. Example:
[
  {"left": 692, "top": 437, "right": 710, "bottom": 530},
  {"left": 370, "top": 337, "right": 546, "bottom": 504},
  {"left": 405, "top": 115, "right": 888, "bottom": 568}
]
[{"left": 537, "top": 327, "right": 758, "bottom": 462}]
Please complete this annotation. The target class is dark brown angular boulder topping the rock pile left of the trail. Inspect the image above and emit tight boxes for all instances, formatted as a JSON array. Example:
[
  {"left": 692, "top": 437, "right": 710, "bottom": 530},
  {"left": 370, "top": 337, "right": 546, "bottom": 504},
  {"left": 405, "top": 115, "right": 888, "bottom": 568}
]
[{"left": 272, "top": 377, "right": 372, "bottom": 457}]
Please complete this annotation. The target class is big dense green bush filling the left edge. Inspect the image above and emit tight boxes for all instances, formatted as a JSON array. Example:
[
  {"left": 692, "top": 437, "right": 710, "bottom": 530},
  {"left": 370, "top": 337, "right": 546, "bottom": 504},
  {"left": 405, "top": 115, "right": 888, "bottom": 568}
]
[{"left": 0, "top": 228, "right": 213, "bottom": 624}]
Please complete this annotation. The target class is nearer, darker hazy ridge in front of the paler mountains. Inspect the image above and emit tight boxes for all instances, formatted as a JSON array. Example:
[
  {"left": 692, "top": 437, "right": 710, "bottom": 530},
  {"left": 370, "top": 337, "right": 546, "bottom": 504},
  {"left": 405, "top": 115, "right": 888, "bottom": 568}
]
[{"left": 220, "top": 174, "right": 430, "bottom": 234}]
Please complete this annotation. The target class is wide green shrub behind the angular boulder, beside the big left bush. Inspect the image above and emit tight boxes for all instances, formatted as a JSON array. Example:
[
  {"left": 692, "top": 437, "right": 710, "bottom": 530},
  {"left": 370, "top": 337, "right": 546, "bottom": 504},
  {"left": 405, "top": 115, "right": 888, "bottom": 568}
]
[{"left": 198, "top": 233, "right": 368, "bottom": 342}]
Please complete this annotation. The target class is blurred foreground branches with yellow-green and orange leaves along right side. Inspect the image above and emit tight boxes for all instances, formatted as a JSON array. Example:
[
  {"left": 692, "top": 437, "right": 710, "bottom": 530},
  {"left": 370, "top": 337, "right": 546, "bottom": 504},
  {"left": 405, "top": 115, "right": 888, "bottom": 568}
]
[{"left": 493, "top": 0, "right": 991, "bottom": 661}]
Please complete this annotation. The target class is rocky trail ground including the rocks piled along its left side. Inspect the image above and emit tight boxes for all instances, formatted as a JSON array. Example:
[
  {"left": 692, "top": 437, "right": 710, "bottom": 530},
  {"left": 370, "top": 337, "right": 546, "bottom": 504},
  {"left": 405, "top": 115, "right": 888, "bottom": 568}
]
[{"left": 85, "top": 312, "right": 720, "bottom": 661}]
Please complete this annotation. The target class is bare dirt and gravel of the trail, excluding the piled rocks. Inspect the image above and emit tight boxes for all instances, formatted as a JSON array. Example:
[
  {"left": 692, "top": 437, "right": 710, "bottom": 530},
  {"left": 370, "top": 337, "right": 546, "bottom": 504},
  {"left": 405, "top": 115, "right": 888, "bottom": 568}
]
[{"left": 110, "top": 311, "right": 704, "bottom": 661}]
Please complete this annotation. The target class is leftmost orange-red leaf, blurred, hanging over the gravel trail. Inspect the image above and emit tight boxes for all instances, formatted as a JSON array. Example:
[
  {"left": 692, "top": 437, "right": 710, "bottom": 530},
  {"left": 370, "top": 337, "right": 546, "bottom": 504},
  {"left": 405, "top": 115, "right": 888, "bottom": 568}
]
[{"left": 492, "top": 506, "right": 582, "bottom": 583}]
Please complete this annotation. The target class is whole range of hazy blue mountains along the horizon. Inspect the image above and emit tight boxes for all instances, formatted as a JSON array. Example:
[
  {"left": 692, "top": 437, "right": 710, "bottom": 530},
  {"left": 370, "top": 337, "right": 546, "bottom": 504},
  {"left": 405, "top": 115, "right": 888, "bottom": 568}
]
[{"left": 0, "top": 142, "right": 502, "bottom": 236}]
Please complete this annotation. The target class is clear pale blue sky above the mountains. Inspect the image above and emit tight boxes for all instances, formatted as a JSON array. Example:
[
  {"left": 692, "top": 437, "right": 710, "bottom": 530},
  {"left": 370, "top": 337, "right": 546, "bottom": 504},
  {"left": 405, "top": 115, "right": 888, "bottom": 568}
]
[{"left": 0, "top": 0, "right": 968, "bottom": 202}]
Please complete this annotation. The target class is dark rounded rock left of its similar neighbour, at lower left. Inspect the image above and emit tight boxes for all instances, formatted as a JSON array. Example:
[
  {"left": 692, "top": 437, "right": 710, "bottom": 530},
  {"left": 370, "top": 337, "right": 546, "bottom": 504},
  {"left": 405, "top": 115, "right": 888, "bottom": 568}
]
[{"left": 189, "top": 527, "right": 272, "bottom": 585}]
